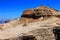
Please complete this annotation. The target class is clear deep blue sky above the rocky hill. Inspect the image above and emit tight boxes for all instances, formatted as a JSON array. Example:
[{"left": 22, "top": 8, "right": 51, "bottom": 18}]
[{"left": 0, "top": 0, "right": 60, "bottom": 19}]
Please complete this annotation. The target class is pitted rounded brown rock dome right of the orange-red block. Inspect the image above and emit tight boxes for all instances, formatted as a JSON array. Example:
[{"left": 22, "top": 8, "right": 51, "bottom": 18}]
[{"left": 33, "top": 6, "right": 58, "bottom": 16}]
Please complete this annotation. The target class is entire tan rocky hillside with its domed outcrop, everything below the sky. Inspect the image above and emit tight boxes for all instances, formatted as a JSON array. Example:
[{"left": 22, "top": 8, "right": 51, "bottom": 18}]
[{"left": 0, "top": 6, "right": 60, "bottom": 40}]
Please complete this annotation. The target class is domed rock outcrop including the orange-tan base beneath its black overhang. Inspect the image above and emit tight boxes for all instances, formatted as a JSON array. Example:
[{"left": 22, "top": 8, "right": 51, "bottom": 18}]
[{"left": 21, "top": 6, "right": 60, "bottom": 23}]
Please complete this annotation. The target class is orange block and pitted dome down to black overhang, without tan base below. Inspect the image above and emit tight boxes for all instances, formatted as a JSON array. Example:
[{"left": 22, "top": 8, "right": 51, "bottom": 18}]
[{"left": 22, "top": 6, "right": 60, "bottom": 19}]
